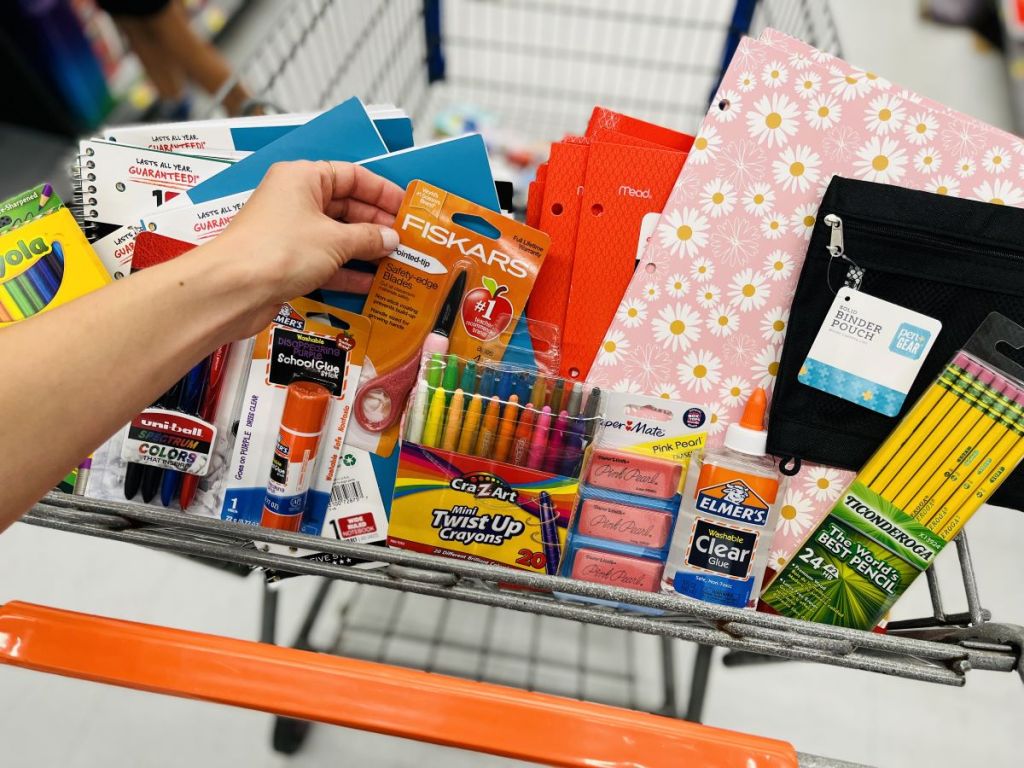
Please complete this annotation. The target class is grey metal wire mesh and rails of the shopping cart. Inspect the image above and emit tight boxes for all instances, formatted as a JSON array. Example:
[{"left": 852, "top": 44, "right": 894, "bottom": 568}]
[{"left": 6, "top": 0, "right": 1024, "bottom": 765}]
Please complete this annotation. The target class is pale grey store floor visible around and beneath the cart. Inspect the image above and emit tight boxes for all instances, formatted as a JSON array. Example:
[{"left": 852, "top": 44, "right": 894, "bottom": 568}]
[{"left": 0, "top": 0, "right": 1024, "bottom": 768}]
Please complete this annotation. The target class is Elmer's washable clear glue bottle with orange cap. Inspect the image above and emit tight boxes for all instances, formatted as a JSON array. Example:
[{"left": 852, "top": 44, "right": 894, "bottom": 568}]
[{"left": 662, "top": 388, "right": 779, "bottom": 608}]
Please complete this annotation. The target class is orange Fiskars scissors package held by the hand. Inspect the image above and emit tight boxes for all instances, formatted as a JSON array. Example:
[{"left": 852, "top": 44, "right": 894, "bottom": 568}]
[{"left": 346, "top": 181, "right": 550, "bottom": 457}]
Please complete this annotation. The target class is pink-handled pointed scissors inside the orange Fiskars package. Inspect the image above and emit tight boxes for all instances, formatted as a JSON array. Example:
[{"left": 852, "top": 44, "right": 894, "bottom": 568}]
[{"left": 355, "top": 269, "right": 466, "bottom": 432}]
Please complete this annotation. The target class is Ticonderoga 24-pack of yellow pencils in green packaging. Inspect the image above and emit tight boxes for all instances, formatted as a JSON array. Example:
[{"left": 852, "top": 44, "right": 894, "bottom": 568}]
[{"left": 760, "top": 312, "right": 1024, "bottom": 630}]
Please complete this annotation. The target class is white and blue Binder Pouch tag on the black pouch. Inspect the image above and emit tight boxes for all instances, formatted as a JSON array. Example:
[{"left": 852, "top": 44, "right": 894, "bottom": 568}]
[{"left": 797, "top": 288, "right": 942, "bottom": 416}]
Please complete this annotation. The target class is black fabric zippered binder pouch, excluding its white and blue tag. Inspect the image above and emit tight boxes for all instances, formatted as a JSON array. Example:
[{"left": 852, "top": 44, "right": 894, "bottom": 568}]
[{"left": 768, "top": 176, "right": 1024, "bottom": 509}]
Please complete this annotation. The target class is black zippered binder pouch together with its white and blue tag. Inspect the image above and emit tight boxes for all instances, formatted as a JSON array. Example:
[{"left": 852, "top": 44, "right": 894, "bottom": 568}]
[{"left": 768, "top": 177, "right": 1024, "bottom": 509}]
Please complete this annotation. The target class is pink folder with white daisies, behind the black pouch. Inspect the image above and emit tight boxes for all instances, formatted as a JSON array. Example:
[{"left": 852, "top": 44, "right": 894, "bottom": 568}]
[{"left": 589, "top": 30, "right": 1024, "bottom": 568}]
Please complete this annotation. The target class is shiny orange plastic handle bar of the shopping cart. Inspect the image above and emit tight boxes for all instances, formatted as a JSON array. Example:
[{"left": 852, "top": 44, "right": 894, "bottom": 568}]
[{"left": 0, "top": 602, "right": 798, "bottom": 768}]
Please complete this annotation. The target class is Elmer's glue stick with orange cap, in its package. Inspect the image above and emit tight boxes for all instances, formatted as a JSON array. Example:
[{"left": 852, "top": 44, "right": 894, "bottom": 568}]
[{"left": 260, "top": 381, "right": 331, "bottom": 530}]
